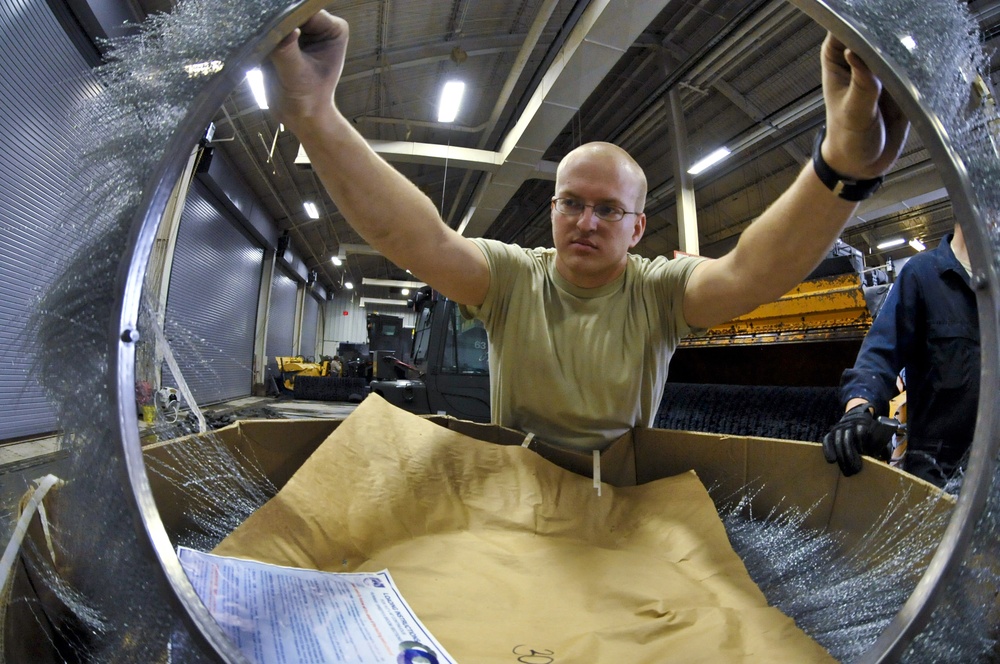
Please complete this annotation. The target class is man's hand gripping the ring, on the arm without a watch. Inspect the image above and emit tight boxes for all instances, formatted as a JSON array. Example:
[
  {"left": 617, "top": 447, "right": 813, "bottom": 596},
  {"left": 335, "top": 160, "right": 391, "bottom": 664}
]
[{"left": 265, "top": 11, "right": 349, "bottom": 132}]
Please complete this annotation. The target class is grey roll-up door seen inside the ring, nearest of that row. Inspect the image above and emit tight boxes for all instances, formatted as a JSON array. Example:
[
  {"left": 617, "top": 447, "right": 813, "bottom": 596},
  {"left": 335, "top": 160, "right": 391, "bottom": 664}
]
[{"left": 163, "top": 181, "right": 264, "bottom": 403}]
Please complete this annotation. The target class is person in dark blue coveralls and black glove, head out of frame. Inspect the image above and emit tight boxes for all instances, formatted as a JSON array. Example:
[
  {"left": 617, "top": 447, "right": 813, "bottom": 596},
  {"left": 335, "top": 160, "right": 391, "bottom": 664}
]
[{"left": 823, "top": 224, "right": 979, "bottom": 486}]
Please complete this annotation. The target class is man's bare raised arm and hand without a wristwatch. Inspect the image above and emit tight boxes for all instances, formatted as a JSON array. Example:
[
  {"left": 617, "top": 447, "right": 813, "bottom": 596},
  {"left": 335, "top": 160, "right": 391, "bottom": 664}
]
[{"left": 267, "top": 11, "right": 489, "bottom": 304}]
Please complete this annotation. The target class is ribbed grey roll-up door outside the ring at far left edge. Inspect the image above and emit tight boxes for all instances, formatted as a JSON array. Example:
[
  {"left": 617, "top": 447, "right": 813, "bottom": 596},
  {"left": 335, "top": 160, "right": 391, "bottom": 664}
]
[{"left": 0, "top": 0, "right": 98, "bottom": 440}]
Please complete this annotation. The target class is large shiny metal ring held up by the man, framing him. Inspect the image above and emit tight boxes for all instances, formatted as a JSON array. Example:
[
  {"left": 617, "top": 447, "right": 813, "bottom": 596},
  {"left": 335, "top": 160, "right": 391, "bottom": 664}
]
[{"left": 111, "top": 0, "right": 1000, "bottom": 663}]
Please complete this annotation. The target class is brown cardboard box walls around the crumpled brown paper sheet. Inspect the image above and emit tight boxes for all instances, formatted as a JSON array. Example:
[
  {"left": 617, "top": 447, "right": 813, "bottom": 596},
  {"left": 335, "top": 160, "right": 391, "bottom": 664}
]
[{"left": 4, "top": 404, "right": 954, "bottom": 662}]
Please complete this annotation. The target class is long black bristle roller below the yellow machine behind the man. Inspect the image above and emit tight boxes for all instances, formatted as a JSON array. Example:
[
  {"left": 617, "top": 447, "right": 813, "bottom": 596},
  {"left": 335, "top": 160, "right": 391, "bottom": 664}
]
[{"left": 654, "top": 383, "right": 843, "bottom": 443}]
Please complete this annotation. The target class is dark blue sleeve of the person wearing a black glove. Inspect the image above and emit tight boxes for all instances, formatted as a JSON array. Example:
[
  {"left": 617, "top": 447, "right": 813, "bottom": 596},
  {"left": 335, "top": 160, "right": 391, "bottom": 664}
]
[{"left": 840, "top": 269, "right": 919, "bottom": 415}]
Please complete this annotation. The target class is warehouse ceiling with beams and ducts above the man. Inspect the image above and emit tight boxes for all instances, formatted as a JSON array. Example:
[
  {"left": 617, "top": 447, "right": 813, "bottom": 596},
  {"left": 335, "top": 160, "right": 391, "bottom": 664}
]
[{"left": 138, "top": 0, "right": 1000, "bottom": 295}]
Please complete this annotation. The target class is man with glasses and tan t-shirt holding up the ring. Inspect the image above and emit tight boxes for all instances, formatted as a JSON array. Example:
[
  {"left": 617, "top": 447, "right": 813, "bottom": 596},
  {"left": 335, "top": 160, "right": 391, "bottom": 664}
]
[{"left": 268, "top": 12, "right": 909, "bottom": 450}]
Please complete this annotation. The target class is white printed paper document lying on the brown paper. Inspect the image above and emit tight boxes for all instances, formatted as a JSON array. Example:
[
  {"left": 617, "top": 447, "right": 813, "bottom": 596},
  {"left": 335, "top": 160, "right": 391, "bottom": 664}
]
[{"left": 177, "top": 547, "right": 455, "bottom": 664}]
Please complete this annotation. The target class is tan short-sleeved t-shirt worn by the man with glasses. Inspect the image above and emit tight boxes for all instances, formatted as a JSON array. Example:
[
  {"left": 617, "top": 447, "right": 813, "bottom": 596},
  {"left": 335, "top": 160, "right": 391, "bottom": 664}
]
[{"left": 463, "top": 238, "right": 703, "bottom": 450}]
